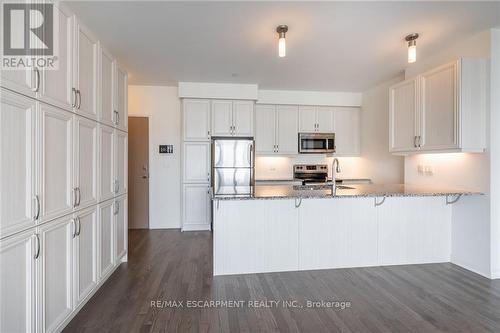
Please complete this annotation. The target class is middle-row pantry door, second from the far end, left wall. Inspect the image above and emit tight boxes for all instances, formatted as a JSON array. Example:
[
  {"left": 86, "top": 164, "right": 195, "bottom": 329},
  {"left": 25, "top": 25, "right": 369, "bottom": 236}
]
[{"left": 99, "top": 125, "right": 115, "bottom": 201}]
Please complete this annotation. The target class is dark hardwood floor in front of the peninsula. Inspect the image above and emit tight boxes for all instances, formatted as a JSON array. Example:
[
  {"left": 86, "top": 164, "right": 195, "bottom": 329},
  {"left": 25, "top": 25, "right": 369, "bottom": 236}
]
[{"left": 65, "top": 230, "right": 500, "bottom": 332}]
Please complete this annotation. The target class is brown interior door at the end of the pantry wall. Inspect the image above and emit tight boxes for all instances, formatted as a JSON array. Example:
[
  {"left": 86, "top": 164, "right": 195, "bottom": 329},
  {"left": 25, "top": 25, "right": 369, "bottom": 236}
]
[{"left": 128, "top": 117, "right": 149, "bottom": 229}]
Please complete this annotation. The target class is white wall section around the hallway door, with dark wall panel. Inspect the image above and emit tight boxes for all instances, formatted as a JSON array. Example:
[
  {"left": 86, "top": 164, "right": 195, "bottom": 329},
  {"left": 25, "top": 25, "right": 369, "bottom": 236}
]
[{"left": 128, "top": 86, "right": 181, "bottom": 229}]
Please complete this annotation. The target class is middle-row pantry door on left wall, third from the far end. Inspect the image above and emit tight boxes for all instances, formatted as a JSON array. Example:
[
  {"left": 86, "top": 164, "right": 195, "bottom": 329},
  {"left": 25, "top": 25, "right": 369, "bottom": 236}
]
[{"left": 73, "top": 116, "right": 97, "bottom": 207}]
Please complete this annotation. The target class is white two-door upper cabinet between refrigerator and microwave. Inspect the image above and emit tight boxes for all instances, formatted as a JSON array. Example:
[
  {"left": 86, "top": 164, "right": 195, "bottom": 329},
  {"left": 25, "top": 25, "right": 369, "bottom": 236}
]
[{"left": 255, "top": 105, "right": 298, "bottom": 155}]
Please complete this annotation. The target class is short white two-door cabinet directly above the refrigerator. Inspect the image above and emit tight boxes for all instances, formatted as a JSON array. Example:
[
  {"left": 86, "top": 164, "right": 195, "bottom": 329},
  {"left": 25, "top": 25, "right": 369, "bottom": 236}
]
[{"left": 212, "top": 100, "right": 253, "bottom": 137}]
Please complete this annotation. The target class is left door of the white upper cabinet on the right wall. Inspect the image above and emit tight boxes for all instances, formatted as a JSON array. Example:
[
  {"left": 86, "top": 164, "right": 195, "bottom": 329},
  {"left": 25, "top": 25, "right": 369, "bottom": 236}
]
[{"left": 389, "top": 79, "right": 419, "bottom": 152}]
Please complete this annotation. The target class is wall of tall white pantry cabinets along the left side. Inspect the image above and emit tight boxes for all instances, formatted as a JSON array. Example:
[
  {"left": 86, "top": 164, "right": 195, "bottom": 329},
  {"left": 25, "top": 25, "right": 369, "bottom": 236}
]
[{"left": 0, "top": 5, "right": 128, "bottom": 332}]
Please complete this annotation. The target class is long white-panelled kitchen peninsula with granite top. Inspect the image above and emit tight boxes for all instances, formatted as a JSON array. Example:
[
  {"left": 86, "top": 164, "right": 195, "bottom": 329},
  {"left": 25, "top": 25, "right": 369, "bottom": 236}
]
[{"left": 213, "top": 184, "right": 481, "bottom": 275}]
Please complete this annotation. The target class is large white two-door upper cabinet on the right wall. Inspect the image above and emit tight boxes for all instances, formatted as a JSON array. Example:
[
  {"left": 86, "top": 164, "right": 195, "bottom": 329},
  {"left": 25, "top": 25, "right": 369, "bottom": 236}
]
[{"left": 390, "top": 59, "right": 487, "bottom": 153}]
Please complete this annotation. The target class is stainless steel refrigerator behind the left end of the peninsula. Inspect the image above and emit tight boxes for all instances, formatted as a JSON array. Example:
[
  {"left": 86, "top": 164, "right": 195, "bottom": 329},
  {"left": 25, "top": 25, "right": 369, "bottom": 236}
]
[{"left": 212, "top": 137, "right": 255, "bottom": 196}]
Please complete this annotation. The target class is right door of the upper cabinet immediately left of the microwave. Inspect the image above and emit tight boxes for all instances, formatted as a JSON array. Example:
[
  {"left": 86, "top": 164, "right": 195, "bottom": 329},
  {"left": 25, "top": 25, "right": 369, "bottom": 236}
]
[{"left": 276, "top": 105, "right": 299, "bottom": 154}]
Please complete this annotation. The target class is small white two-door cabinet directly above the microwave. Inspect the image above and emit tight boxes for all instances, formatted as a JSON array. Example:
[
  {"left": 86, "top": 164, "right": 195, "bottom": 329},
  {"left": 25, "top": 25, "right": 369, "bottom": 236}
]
[{"left": 299, "top": 106, "right": 334, "bottom": 133}]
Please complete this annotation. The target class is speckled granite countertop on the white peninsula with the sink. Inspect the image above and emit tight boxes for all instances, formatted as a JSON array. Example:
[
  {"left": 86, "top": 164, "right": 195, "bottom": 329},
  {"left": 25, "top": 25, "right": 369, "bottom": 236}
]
[{"left": 212, "top": 184, "right": 483, "bottom": 200}]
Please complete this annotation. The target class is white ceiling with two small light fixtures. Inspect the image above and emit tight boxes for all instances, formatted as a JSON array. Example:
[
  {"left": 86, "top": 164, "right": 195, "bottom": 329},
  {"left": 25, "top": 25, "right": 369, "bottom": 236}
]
[{"left": 69, "top": 1, "right": 500, "bottom": 91}]
